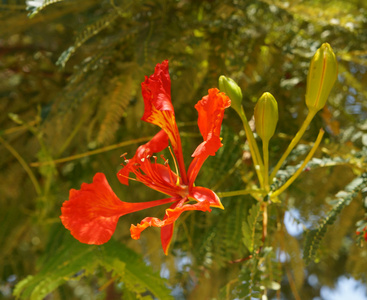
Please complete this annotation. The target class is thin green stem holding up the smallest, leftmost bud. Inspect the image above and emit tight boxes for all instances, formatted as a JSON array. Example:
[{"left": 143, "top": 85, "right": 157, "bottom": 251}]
[{"left": 239, "top": 106, "right": 264, "bottom": 188}]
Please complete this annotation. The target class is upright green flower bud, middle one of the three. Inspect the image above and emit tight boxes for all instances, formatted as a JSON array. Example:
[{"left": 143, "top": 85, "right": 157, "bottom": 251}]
[{"left": 254, "top": 93, "right": 278, "bottom": 143}]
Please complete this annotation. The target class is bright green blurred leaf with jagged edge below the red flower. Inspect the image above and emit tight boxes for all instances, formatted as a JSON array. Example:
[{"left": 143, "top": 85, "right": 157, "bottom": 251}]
[{"left": 14, "top": 225, "right": 171, "bottom": 300}]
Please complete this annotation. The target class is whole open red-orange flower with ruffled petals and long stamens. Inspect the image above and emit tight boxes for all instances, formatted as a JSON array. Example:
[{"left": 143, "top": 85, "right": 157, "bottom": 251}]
[{"left": 60, "top": 61, "right": 230, "bottom": 254}]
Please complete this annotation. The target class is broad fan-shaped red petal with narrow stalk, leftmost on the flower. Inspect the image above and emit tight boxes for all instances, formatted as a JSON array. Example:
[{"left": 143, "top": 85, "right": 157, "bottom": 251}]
[{"left": 60, "top": 173, "right": 176, "bottom": 245}]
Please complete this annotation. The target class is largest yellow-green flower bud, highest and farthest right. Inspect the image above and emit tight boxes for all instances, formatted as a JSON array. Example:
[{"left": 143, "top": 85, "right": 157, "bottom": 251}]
[{"left": 306, "top": 43, "right": 338, "bottom": 113}]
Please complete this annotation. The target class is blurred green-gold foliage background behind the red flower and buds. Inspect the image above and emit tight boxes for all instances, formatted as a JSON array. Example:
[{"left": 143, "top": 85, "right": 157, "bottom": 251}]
[{"left": 0, "top": 0, "right": 367, "bottom": 299}]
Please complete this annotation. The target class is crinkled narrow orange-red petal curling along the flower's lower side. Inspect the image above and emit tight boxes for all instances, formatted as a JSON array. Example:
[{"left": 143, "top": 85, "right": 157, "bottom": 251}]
[{"left": 130, "top": 199, "right": 211, "bottom": 240}]
